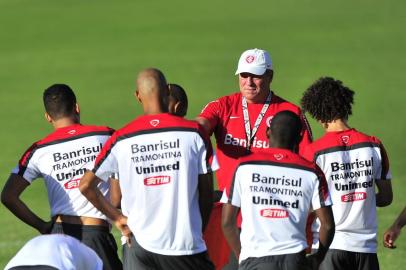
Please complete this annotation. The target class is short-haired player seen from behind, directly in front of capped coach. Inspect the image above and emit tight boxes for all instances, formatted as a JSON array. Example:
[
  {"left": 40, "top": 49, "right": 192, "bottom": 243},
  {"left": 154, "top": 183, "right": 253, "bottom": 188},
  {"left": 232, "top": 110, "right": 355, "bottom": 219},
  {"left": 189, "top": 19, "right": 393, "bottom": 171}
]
[{"left": 222, "top": 111, "right": 334, "bottom": 270}]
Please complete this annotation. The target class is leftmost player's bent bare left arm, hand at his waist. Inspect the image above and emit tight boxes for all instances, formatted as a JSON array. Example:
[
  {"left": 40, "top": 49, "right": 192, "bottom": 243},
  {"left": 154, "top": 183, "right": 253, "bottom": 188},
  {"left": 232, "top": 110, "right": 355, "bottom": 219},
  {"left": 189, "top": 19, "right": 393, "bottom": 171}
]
[{"left": 1, "top": 174, "right": 52, "bottom": 234}]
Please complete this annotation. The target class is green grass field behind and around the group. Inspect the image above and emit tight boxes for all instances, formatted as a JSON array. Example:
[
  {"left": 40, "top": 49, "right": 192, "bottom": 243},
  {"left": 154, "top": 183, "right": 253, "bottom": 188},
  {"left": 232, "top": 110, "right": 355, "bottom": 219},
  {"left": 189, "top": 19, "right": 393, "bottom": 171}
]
[{"left": 0, "top": 0, "right": 406, "bottom": 270}]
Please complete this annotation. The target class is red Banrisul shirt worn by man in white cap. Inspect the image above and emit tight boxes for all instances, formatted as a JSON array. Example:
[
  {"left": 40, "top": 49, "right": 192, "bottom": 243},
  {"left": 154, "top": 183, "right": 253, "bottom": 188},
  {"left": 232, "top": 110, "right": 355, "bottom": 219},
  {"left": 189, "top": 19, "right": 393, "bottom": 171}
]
[{"left": 199, "top": 93, "right": 312, "bottom": 190}]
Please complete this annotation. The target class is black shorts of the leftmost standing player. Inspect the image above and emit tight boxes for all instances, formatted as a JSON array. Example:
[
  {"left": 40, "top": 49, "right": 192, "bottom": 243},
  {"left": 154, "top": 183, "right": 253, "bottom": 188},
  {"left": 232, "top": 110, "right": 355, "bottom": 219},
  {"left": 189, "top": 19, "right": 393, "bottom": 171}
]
[{"left": 51, "top": 223, "right": 123, "bottom": 270}]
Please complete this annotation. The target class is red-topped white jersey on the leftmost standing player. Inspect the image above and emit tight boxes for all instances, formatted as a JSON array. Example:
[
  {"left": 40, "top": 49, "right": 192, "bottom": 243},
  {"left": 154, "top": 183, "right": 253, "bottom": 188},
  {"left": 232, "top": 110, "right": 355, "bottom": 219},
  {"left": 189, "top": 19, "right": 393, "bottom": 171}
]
[{"left": 12, "top": 124, "right": 113, "bottom": 219}]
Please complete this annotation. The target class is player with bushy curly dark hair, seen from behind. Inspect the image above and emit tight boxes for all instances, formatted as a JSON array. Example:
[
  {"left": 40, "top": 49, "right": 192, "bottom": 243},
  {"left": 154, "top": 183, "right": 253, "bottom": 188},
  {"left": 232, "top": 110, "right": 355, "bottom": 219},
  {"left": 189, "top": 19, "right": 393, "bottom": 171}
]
[{"left": 301, "top": 77, "right": 392, "bottom": 270}]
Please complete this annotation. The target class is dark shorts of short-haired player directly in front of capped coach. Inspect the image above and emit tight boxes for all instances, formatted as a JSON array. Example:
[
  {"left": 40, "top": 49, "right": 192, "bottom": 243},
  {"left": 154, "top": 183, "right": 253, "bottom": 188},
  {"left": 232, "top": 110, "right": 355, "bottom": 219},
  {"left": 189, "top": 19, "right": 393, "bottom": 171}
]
[{"left": 238, "top": 251, "right": 310, "bottom": 270}]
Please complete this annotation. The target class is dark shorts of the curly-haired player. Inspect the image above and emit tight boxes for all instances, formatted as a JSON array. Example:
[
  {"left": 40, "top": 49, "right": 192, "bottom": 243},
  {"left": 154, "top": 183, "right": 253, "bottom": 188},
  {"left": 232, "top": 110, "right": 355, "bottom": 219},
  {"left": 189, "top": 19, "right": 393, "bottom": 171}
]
[{"left": 319, "top": 249, "right": 379, "bottom": 270}]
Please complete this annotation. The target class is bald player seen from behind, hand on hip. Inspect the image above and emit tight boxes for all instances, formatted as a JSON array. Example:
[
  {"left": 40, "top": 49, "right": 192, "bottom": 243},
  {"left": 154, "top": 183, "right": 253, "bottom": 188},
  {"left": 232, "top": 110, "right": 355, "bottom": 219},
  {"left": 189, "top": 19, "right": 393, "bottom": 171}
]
[{"left": 80, "top": 68, "right": 214, "bottom": 270}]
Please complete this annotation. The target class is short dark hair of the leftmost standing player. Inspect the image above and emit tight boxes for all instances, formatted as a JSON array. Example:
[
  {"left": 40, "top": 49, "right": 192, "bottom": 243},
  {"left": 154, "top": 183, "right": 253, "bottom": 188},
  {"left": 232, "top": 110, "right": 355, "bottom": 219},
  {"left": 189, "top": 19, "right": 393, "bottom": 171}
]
[{"left": 43, "top": 84, "right": 76, "bottom": 120}]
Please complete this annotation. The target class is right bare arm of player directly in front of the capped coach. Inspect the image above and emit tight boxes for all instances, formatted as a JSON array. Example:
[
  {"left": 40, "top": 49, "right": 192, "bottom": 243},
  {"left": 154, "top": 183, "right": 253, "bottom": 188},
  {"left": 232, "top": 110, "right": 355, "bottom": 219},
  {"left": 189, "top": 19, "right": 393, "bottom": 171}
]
[{"left": 312, "top": 206, "right": 335, "bottom": 269}]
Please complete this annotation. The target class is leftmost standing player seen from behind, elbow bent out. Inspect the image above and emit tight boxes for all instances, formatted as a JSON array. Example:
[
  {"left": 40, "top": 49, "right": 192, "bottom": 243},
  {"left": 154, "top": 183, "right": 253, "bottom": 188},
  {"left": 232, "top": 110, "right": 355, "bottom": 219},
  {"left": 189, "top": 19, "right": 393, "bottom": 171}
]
[{"left": 1, "top": 84, "right": 122, "bottom": 270}]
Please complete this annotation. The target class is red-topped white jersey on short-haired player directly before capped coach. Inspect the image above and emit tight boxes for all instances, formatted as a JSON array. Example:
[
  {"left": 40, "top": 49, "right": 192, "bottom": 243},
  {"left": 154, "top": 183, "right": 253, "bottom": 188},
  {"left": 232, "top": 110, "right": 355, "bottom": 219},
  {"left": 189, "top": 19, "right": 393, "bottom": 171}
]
[{"left": 224, "top": 148, "right": 331, "bottom": 262}]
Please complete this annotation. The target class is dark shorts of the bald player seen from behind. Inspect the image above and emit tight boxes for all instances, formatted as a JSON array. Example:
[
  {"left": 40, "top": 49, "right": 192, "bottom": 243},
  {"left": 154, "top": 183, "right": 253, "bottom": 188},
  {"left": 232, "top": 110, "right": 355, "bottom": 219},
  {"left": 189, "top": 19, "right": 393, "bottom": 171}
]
[{"left": 123, "top": 236, "right": 214, "bottom": 270}]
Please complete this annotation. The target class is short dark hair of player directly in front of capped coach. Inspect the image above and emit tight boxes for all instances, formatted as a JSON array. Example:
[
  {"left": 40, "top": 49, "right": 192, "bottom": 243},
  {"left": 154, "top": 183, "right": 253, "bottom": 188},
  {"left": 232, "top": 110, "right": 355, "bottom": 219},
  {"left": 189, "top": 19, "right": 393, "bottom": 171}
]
[{"left": 269, "top": 111, "right": 302, "bottom": 149}]
